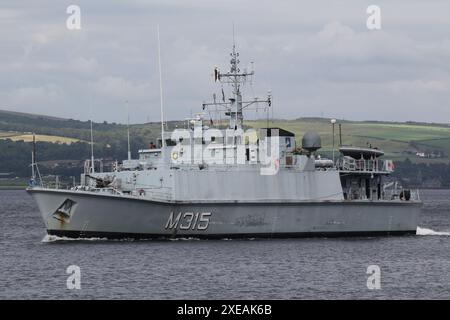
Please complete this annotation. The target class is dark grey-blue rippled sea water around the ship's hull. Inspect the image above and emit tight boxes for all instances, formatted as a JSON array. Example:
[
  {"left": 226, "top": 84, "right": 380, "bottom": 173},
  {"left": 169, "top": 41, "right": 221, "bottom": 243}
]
[{"left": 0, "top": 190, "right": 450, "bottom": 299}]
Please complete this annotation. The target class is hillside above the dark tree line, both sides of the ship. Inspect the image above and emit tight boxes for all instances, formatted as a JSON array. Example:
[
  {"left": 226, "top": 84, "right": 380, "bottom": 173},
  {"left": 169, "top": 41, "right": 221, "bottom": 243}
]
[{"left": 0, "top": 110, "right": 450, "bottom": 163}]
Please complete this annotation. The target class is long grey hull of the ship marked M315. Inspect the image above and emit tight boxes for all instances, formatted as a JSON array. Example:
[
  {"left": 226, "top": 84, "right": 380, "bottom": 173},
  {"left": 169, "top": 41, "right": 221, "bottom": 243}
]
[{"left": 28, "top": 189, "right": 422, "bottom": 239}]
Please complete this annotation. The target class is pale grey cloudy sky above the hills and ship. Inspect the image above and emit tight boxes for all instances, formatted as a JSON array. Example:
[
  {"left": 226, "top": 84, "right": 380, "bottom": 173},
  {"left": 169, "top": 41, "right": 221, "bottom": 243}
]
[{"left": 0, "top": 0, "right": 450, "bottom": 123}]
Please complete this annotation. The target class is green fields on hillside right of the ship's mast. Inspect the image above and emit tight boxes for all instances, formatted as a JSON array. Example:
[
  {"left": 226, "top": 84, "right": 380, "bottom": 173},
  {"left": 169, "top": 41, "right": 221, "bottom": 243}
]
[{"left": 247, "top": 119, "right": 450, "bottom": 162}]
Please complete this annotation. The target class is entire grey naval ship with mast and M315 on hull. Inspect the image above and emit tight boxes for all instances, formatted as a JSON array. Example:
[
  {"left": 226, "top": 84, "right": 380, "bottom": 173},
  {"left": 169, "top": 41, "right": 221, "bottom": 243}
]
[{"left": 27, "top": 45, "right": 422, "bottom": 239}]
